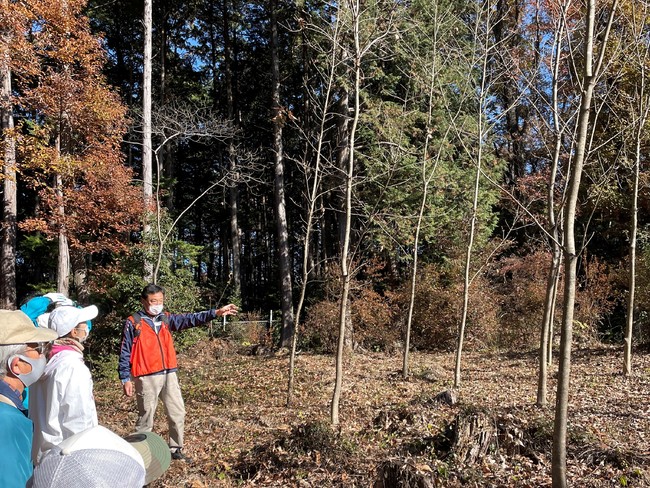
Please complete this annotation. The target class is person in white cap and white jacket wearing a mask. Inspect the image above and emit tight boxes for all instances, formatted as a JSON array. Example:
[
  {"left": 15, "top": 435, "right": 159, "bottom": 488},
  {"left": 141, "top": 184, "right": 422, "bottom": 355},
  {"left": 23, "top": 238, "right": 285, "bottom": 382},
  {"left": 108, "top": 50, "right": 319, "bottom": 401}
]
[{"left": 29, "top": 305, "right": 98, "bottom": 464}]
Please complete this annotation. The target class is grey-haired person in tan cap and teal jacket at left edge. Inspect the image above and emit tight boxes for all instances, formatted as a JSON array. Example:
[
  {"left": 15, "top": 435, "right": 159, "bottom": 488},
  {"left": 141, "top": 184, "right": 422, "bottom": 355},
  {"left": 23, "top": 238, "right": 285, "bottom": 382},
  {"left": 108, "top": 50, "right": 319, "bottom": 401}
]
[{"left": 0, "top": 310, "right": 57, "bottom": 488}]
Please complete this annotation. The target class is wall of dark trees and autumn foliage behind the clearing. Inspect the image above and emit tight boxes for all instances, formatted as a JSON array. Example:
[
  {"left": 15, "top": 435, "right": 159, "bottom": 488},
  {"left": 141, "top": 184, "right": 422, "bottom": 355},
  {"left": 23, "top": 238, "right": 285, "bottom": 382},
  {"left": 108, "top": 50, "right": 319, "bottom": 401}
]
[{"left": 2, "top": 0, "right": 650, "bottom": 353}]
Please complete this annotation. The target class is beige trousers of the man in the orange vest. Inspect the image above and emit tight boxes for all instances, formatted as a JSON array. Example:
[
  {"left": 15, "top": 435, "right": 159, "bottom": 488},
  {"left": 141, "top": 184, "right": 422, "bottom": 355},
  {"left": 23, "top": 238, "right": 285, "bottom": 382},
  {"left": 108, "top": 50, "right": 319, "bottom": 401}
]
[{"left": 133, "top": 372, "right": 185, "bottom": 449}]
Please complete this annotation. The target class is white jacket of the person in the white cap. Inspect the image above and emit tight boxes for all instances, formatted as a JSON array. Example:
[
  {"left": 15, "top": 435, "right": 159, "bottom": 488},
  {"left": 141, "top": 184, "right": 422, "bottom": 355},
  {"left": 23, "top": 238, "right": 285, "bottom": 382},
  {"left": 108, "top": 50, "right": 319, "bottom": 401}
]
[{"left": 29, "top": 349, "right": 97, "bottom": 464}]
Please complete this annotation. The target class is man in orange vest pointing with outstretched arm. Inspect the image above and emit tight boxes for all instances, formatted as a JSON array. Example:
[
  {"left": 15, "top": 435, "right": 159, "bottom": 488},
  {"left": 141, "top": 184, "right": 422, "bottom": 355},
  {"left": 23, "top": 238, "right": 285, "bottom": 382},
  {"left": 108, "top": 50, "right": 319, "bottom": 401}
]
[{"left": 118, "top": 284, "right": 237, "bottom": 461}]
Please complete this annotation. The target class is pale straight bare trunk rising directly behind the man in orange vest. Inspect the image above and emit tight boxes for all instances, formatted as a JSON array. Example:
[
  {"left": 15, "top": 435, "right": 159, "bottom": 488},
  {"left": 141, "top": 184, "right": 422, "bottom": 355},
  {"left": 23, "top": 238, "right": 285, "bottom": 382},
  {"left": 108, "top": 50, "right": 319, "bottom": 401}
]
[{"left": 142, "top": 0, "right": 155, "bottom": 282}]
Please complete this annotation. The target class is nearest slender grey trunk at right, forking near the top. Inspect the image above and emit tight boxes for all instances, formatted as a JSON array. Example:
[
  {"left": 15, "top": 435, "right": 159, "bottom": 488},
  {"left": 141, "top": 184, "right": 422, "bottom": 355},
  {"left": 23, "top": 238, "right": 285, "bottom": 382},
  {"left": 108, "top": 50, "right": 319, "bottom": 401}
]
[{"left": 551, "top": 0, "right": 618, "bottom": 488}]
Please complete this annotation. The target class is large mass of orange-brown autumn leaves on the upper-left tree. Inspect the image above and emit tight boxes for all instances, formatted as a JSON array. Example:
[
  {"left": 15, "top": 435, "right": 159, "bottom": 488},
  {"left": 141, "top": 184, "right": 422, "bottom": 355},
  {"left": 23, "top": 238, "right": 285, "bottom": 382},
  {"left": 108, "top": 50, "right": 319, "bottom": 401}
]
[{"left": 5, "top": 0, "right": 142, "bottom": 254}]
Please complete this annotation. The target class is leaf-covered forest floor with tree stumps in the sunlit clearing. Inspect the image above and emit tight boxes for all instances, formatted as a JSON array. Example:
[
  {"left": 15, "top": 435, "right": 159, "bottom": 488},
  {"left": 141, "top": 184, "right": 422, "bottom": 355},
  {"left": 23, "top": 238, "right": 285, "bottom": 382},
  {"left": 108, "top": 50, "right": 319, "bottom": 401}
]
[{"left": 95, "top": 340, "right": 650, "bottom": 488}]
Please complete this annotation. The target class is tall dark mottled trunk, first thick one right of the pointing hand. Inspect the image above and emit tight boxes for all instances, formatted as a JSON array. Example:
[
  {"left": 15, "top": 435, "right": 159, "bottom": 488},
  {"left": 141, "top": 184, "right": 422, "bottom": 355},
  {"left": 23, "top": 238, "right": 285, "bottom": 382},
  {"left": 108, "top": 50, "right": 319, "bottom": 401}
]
[{"left": 270, "top": 0, "right": 294, "bottom": 348}]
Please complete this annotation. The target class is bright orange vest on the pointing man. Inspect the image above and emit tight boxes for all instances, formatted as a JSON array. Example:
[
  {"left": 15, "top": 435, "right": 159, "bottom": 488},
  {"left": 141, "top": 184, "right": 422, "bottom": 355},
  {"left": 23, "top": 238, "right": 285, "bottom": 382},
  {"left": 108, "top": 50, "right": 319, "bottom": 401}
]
[{"left": 129, "top": 316, "right": 178, "bottom": 376}]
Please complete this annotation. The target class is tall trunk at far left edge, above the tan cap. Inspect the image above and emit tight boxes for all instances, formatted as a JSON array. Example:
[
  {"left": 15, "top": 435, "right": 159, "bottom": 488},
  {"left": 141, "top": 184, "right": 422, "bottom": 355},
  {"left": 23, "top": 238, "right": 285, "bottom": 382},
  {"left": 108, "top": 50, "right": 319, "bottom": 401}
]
[{"left": 0, "top": 20, "right": 18, "bottom": 310}]
